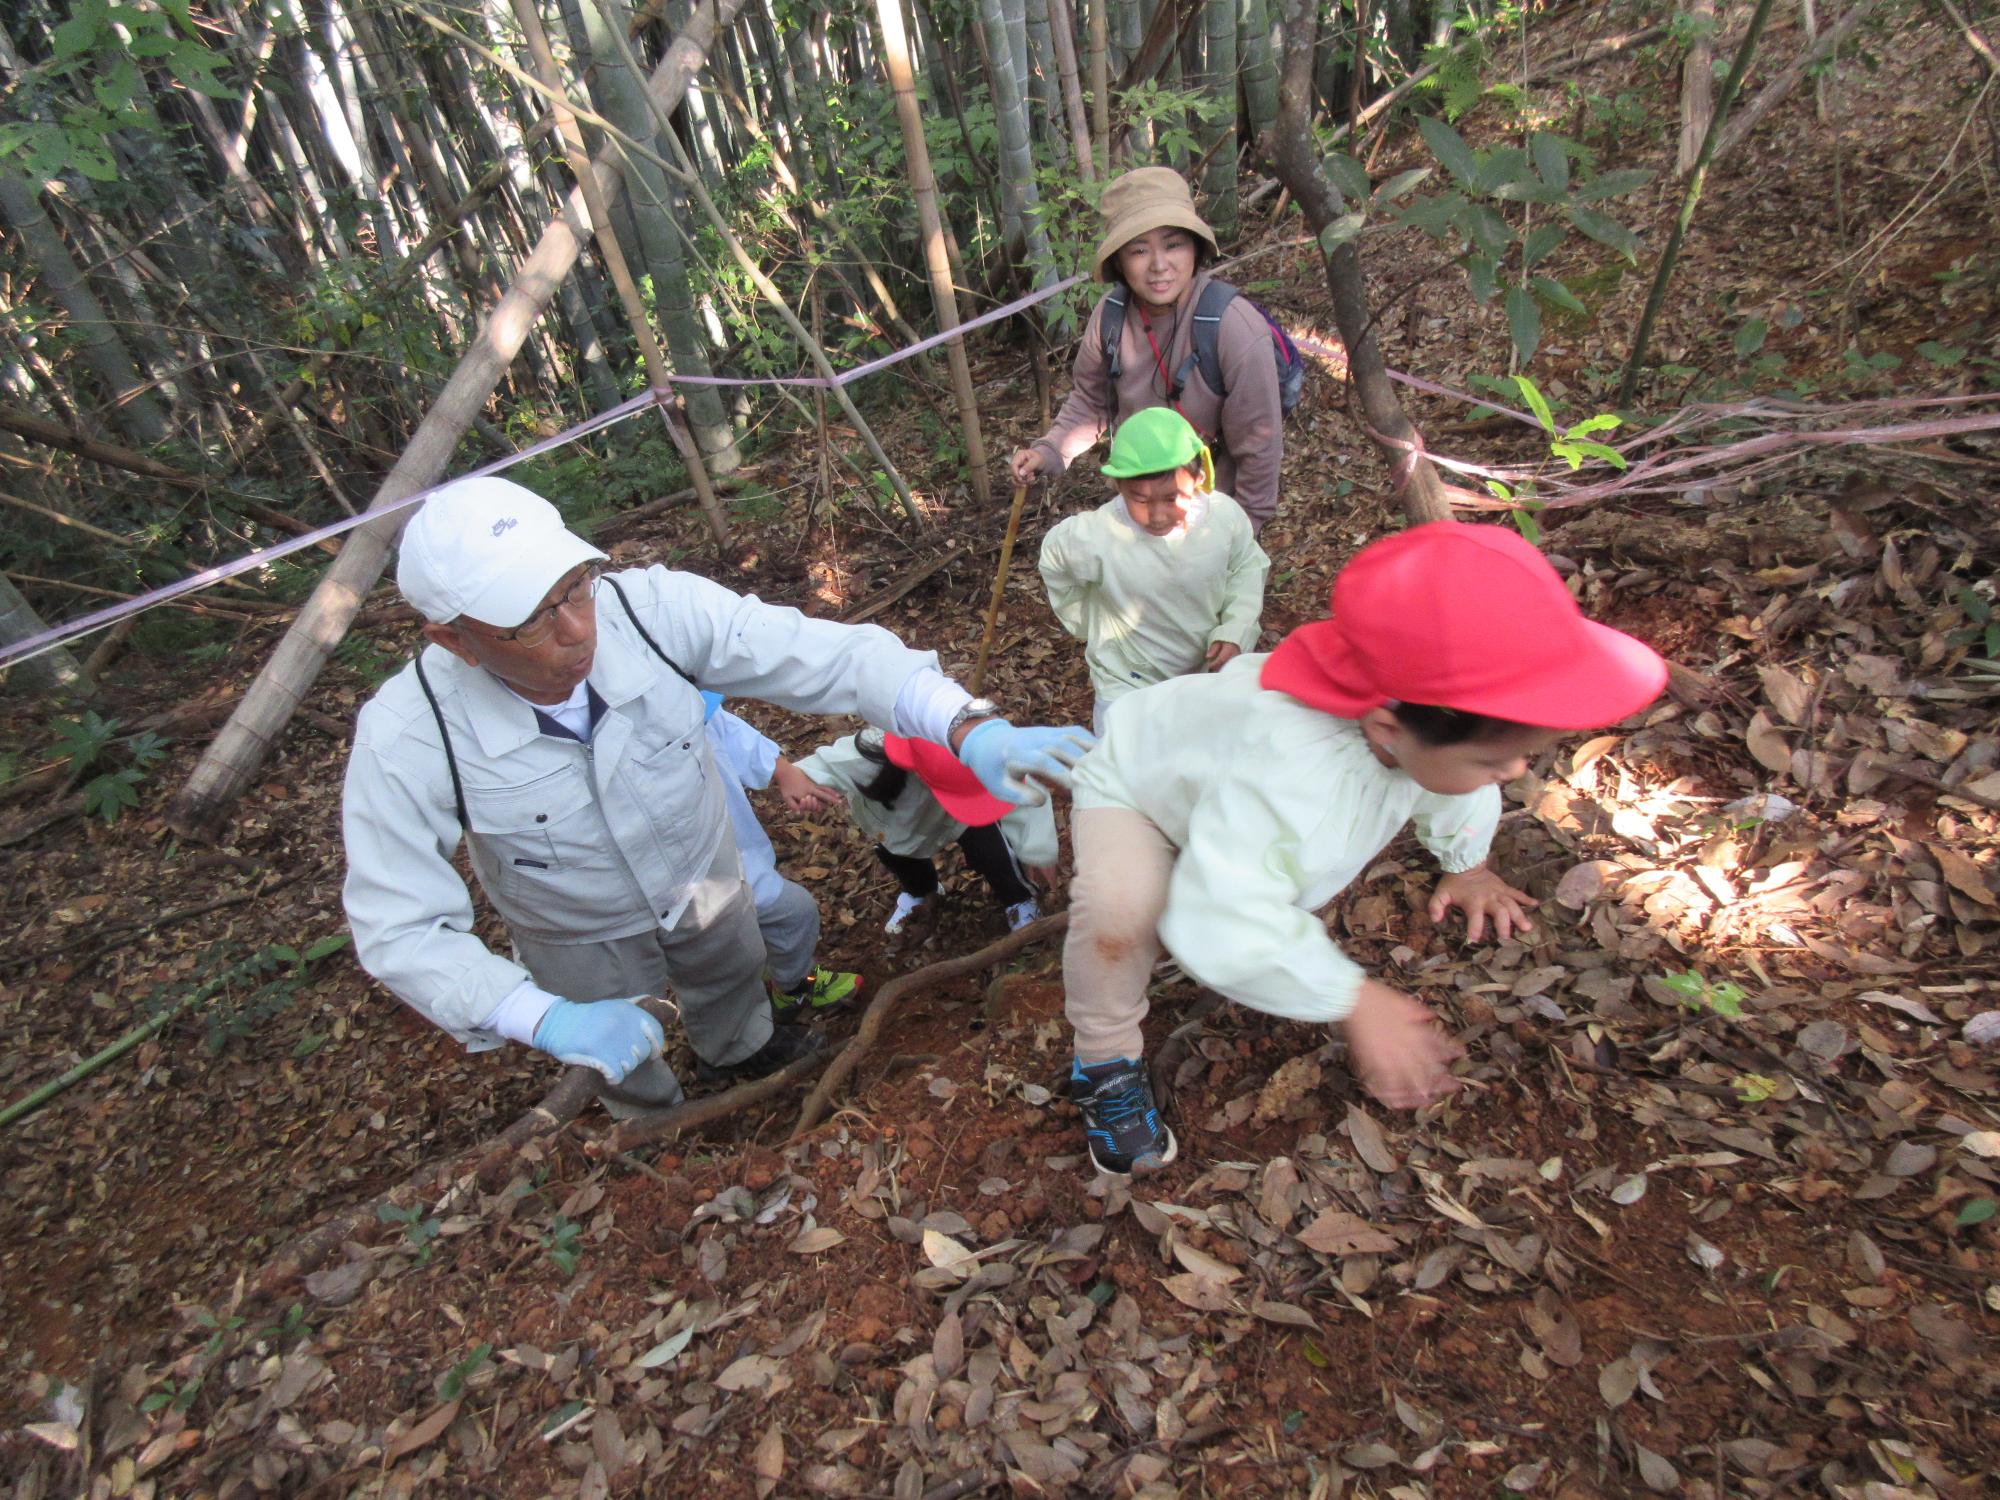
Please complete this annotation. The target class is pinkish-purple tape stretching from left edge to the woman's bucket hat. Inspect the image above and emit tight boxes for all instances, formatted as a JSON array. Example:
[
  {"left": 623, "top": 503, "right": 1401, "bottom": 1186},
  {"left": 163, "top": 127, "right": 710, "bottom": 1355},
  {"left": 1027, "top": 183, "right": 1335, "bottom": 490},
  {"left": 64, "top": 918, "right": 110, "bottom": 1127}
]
[{"left": 0, "top": 274, "right": 1084, "bottom": 668}]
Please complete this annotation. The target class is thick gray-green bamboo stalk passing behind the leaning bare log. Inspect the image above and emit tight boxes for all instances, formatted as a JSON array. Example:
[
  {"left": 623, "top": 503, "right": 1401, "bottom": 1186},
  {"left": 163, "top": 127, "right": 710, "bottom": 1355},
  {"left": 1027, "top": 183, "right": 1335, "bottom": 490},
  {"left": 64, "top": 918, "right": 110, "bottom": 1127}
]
[{"left": 578, "top": 0, "right": 742, "bottom": 474}]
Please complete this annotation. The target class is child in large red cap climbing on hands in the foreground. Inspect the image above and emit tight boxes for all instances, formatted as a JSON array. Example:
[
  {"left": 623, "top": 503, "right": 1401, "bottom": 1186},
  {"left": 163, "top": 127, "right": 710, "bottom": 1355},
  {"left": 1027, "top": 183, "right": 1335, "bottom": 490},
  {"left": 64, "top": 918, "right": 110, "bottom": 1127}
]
[{"left": 1062, "top": 522, "right": 1666, "bottom": 1172}]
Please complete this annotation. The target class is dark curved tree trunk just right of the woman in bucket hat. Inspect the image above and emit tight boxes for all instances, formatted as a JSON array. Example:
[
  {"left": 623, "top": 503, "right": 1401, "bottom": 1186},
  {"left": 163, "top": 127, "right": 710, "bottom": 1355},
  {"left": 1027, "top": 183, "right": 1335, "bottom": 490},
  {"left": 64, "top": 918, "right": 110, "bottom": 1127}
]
[{"left": 1272, "top": 0, "right": 1452, "bottom": 526}]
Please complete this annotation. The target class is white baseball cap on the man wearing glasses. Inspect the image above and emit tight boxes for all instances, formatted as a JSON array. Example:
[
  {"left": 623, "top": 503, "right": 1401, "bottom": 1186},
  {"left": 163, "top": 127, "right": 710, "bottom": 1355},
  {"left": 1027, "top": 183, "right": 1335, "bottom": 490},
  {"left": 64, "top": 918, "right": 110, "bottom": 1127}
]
[{"left": 396, "top": 478, "right": 604, "bottom": 630}]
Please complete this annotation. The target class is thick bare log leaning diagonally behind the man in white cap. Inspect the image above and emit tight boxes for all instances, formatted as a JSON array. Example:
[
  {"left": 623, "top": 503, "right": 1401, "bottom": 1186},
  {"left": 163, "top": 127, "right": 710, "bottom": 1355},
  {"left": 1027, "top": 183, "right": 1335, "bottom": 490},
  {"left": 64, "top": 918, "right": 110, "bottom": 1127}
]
[{"left": 170, "top": 0, "right": 742, "bottom": 836}]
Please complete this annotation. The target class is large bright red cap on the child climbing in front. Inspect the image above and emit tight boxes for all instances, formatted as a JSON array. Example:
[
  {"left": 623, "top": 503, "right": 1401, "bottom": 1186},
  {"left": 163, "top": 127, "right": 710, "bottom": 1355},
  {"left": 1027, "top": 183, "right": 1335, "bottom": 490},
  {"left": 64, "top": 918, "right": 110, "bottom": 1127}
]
[{"left": 1260, "top": 520, "right": 1666, "bottom": 730}]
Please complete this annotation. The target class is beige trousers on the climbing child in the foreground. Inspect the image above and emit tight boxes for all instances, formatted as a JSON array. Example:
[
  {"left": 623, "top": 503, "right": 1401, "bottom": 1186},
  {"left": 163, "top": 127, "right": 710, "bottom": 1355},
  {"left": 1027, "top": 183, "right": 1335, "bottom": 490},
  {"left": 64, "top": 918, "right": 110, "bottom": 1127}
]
[{"left": 1062, "top": 808, "right": 1180, "bottom": 1068}]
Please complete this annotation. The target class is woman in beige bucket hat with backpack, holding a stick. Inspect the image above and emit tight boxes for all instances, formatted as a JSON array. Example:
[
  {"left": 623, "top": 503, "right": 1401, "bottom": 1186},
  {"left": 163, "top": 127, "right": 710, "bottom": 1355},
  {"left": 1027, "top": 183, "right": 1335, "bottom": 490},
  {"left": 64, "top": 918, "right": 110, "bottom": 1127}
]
[{"left": 1010, "top": 166, "right": 1284, "bottom": 528}]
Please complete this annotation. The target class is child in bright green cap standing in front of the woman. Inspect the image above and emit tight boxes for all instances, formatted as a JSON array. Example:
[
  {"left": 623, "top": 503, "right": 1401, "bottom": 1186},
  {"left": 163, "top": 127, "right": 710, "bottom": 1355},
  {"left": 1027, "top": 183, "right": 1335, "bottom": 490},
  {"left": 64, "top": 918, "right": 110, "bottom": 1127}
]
[{"left": 1040, "top": 406, "right": 1270, "bottom": 734}]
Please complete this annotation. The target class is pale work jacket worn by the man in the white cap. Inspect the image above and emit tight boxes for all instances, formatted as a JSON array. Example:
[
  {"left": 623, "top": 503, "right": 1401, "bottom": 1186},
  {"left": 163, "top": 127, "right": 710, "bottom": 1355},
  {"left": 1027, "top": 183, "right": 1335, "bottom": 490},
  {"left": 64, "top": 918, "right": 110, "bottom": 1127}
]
[{"left": 342, "top": 568, "right": 938, "bottom": 1046}]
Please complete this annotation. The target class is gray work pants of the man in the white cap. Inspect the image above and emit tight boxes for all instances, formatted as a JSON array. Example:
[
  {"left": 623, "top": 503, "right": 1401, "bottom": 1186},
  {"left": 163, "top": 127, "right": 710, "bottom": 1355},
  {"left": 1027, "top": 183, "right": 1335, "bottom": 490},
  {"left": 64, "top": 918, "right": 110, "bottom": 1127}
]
[{"left": 514, "top": 836, "right": 772, "bottom": 1108}]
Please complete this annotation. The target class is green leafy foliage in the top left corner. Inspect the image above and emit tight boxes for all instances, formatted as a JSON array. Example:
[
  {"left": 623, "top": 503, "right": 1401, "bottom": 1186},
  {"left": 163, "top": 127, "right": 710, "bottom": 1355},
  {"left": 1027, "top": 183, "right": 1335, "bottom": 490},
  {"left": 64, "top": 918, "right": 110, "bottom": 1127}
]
[{"left": 0, "top": 0, "right": 236, "bottom": 182}]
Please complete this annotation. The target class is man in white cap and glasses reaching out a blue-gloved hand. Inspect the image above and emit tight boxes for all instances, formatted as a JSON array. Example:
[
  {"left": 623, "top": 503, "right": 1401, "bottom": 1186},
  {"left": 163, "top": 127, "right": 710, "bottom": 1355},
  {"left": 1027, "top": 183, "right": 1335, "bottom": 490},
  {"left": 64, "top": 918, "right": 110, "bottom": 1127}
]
[{"left": 342, "top": 478, "right": 1090, "bottom": 1114}]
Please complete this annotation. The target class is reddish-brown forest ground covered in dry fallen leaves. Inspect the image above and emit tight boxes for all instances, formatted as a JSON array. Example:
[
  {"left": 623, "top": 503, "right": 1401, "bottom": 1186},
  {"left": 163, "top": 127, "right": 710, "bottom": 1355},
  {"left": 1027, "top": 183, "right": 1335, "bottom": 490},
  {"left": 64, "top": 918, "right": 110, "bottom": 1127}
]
[{"left": 0, "top": 11, "right": 2000, "bottom": 1500}]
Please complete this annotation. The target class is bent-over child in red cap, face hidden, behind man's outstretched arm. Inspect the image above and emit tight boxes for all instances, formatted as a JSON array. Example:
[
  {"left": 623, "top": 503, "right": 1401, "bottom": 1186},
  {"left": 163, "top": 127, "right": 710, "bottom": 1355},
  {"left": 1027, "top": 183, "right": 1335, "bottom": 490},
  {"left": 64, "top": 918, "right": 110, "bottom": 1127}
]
[{"left": 798, "top": 728, "right": 1056, "bottom": 934}]
